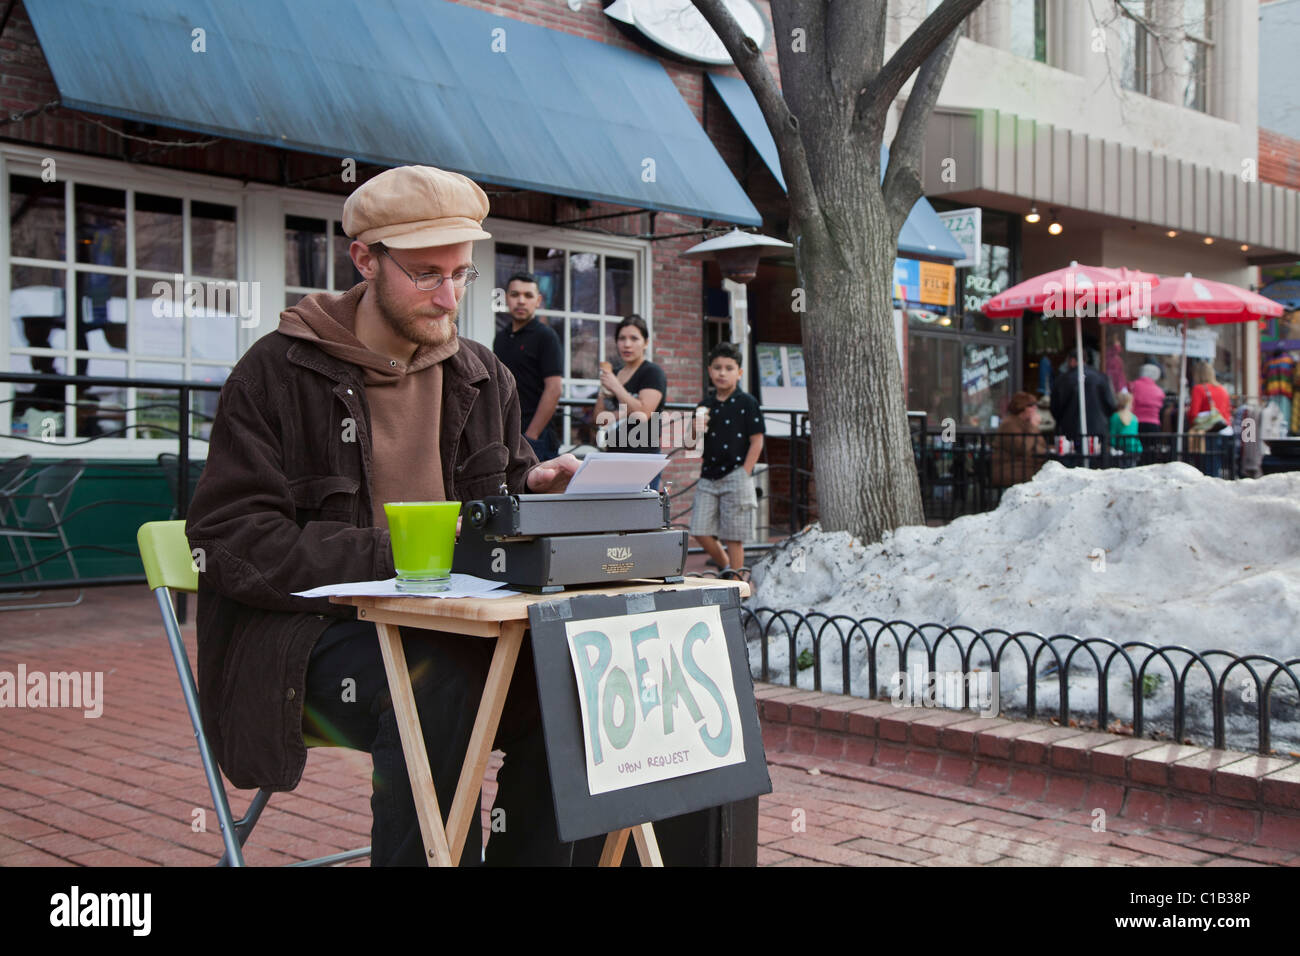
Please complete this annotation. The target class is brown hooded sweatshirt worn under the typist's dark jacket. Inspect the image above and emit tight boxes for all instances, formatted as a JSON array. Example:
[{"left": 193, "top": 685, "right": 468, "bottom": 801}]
[{"left": 280, "top": 282, "right": 460, "bottom": 528}]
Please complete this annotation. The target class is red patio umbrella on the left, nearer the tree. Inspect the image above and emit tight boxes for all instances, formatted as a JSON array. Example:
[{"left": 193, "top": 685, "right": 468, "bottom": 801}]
[{"left": 983, "top": 261, "right": 1160, "bottom": 451}]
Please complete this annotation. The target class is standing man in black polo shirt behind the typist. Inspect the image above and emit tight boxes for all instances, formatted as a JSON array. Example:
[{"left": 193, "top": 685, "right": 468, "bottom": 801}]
[{"left": 491, "top": 272, "right": 564, "bottom": 462}]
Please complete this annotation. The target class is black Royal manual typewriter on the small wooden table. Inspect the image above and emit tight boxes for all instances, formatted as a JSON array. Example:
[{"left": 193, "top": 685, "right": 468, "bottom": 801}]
[{"left": 451, "top": 486, "right": 686, "bottom": 594}]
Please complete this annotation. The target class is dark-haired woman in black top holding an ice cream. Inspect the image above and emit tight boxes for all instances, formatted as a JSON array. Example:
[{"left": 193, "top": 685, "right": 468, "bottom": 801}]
[{"left": 597, "top": 315, "right": 668, "bottom": 486}]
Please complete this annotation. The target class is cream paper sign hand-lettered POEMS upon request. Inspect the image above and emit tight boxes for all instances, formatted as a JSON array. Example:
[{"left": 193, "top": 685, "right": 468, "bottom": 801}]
[{"left": 564, "top": 605, "right": 745, "bottom": 793}]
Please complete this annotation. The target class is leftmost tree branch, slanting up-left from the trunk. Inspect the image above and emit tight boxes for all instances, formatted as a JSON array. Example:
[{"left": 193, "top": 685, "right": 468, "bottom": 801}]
[{"left": 693, "top": 0, "right": 826, "bottom": 222}]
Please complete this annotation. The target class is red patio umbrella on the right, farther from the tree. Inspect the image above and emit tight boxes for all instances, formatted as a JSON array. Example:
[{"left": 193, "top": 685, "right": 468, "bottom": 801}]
[{"left": 1101, "top": 272, "right": 1283, "bottom": 451}]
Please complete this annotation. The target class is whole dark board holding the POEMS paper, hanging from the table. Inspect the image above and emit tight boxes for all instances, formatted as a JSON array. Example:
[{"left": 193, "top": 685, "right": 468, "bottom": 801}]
[{"left": 529, "top": 588, "right": 772, "bottom": 842}]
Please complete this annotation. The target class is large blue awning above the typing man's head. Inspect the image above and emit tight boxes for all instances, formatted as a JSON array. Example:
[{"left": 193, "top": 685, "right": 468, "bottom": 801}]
[{"left": 26, "top": 0, "right": 761, "bottom": 225}]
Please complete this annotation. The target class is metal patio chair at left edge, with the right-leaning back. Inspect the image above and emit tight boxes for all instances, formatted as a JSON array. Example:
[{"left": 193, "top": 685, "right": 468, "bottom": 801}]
[{"left": 0, "top": 458, "right": 86, "bottom": 611}]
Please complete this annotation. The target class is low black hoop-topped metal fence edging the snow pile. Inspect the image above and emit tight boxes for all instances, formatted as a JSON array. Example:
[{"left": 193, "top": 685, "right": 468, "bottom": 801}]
[{"left": 741, "top": 607, "right": 1300, "bottom": 757}]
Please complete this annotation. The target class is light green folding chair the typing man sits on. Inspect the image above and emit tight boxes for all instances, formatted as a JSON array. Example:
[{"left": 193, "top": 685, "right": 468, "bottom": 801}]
[{"left": 135, "top": 520, "right": 371, "bottom": 866}]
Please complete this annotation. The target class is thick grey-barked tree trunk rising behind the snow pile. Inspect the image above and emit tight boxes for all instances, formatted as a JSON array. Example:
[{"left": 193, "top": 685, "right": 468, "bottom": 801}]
[{"left": 694, "top": 0, "right": 982, "bottom": 541}]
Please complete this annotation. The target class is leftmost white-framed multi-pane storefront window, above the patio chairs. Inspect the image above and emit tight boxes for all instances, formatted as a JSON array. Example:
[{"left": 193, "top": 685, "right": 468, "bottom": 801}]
[{"left": 7, "top": 171, "right": 241, "bottom": 442}]
